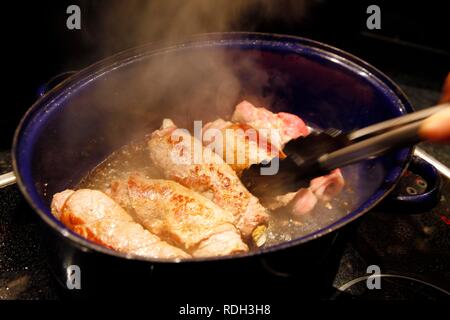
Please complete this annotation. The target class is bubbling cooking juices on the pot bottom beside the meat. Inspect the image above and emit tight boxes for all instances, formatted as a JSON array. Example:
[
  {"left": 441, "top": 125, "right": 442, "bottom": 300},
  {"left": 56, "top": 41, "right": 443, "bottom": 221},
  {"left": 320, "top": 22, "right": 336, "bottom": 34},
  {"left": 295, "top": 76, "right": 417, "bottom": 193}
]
[{"left": 77, "top": 137, "right": 354, "bottom": 250}]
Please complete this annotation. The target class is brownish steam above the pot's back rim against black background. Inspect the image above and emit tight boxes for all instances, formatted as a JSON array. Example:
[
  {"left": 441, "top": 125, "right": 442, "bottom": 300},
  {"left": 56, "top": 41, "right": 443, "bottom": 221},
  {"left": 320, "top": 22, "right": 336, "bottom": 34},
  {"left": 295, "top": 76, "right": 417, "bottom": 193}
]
[{"left": 85, "top": 0, "right": 315, "bottom": 55}]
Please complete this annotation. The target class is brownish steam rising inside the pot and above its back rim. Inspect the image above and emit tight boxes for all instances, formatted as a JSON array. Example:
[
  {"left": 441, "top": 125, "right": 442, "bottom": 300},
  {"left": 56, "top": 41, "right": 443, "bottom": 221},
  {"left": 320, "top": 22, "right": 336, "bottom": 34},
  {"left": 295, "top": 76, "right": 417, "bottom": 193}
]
[{"left": 45, "top": 0, "right": 316, "bottom": 194}]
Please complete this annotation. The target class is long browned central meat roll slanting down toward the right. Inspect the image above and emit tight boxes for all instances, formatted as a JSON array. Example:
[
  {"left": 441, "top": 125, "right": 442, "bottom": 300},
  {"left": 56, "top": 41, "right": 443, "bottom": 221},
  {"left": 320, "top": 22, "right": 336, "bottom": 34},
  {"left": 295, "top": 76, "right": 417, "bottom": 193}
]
[{"left": 148, "top": 120, "right": 268, "bottom": 245}]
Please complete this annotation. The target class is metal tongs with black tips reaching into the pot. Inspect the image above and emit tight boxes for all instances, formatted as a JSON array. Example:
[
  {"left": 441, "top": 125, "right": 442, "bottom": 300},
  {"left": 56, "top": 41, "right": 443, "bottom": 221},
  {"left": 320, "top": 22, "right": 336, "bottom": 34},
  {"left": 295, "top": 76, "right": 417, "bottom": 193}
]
[{"left": 241, "top": 104, "right": 450, "bottom": 196}]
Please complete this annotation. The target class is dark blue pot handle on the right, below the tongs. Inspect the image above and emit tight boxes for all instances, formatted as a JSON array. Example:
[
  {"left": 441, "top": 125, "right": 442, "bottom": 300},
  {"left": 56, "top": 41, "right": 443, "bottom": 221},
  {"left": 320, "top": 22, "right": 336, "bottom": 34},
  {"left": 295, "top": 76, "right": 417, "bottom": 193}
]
[{"left": 386, "top": 148, "right": 449, "bottom": 213}]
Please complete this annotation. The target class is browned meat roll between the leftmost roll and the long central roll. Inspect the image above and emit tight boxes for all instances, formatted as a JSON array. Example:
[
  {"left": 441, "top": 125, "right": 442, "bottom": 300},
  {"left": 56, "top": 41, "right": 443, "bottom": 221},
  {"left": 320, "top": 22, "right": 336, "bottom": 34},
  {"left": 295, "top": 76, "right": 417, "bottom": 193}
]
[{"left": 111, "top": 175, "right": 248, "bottom": 257}]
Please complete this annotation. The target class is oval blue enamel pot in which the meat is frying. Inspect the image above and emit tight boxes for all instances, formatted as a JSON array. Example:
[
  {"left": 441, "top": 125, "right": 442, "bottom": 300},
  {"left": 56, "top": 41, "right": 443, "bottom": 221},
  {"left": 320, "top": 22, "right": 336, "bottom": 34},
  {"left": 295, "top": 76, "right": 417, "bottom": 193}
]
[{"left": 1, "top": 33, "right": 442, "bottom": 298}]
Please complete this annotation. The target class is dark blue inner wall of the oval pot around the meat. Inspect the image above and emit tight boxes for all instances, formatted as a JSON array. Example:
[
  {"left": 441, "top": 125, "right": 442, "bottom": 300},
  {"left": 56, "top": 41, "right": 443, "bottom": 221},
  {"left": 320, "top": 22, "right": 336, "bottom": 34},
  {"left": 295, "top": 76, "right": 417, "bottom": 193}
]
[{"left": 15, "top": 35, "right": 411, "bottom": 251}]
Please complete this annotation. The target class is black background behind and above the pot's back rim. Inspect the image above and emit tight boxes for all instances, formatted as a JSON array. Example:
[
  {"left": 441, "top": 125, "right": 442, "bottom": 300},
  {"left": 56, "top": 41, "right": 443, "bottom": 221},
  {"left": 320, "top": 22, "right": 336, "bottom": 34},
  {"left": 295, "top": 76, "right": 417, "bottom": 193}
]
[{"left": 0, "top": 0, "right": 450, "bottom": 150}]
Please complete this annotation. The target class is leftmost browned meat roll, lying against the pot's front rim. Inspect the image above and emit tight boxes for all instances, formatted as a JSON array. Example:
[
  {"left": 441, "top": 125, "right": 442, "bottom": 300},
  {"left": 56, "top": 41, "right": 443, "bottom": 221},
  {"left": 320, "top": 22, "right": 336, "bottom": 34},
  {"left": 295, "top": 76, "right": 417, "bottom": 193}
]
[{"left": 51, "top": 189, "right": 190, "bottom": 259}]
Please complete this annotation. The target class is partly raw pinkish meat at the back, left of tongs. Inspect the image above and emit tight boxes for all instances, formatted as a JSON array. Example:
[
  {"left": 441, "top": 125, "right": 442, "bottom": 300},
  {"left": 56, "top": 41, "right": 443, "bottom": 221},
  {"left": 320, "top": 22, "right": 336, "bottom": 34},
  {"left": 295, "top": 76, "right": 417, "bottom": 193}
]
[{"left": 202, "top": 101, "right": 308, "bottom": 175}]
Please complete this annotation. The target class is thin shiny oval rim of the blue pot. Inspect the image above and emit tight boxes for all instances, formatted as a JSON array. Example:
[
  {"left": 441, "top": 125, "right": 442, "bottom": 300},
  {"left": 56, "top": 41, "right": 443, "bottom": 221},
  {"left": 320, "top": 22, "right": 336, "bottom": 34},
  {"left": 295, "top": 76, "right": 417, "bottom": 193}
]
[{"left": 12, "top": 32, "right": 413, "bottom": 264}]
